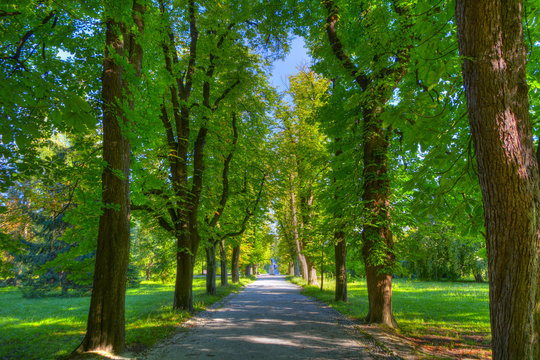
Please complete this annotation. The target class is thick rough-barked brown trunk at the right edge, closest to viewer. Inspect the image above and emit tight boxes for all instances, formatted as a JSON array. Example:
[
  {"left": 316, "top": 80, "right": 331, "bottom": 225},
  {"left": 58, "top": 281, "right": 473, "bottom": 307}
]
[{"left": 456, "top": 0, "right": 540, "bottom": 359}]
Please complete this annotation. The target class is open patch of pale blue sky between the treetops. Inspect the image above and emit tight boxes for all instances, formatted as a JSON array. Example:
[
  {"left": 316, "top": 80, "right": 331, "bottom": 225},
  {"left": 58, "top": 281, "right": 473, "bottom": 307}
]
[{"left": 270, "top": 37, "right": 311, "bottom": 92}]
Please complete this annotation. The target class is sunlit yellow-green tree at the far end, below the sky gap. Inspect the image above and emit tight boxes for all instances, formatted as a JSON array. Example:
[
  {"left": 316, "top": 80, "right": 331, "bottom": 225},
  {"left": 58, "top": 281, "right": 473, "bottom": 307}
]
[{"left": 276, "top": 69, "right": 329, "bottom": 285}]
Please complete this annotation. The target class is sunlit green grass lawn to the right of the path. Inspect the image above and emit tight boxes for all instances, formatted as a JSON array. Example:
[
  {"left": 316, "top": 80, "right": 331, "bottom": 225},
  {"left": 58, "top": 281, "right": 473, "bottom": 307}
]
[{"left": 290, "top": 278, "right": 491, "bottom": 353}]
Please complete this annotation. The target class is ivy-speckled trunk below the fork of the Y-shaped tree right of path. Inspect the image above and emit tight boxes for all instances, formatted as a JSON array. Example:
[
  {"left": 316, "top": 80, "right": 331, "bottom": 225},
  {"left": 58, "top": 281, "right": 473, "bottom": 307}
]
[{"left": 362, "top": 104, "right": 397, "bottom": 327}]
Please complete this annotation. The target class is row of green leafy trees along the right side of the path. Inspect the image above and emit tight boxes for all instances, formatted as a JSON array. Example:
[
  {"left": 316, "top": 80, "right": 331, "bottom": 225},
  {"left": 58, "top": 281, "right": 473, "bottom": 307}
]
[{"left": 270, "top": 0, "right": 540, "bottom": 359}]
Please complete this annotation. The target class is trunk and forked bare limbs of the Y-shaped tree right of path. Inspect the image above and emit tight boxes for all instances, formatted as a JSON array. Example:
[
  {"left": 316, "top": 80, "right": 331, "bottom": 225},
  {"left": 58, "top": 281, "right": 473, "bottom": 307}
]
[{"left": 323, "top": 0, "right": 412, "bottom": 327}]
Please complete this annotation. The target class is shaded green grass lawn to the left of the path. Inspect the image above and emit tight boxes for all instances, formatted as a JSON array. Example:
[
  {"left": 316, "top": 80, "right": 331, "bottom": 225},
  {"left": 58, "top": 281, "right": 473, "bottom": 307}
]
[{"left": 0, "top": 277, "right": 251, "bottom": 359}]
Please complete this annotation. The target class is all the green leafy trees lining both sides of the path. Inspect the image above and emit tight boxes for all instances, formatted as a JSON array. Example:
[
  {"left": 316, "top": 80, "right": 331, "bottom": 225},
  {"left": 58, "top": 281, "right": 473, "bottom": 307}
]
[{"left": 0, "top": 0, "right": 540, "bottom": 359}]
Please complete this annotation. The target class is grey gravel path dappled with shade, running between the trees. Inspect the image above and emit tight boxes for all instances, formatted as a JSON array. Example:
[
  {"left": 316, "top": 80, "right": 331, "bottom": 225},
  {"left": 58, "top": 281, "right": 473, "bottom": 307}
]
[{"left": 142, "top": 275, "right": 370, "bottom": 360}]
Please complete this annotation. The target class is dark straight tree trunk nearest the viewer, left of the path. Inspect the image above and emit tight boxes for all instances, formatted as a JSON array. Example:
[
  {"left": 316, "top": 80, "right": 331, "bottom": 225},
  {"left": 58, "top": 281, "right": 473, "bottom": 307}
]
[{"left": 74, "top": 1, "right": 145, "bottom": 353}]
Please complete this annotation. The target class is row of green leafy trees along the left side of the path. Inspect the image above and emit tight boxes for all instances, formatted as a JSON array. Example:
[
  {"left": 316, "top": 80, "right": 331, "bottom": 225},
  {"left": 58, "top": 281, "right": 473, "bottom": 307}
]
[{"left": 0, "top": 1, "right": 287, "bottom": 352}]
